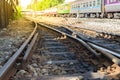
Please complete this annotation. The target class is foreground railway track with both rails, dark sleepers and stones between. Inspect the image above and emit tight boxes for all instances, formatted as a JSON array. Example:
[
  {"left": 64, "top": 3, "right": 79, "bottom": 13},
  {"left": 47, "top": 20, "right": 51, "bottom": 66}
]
[{"left": 0, "top": 20, "right": 120, "bottom": 80}]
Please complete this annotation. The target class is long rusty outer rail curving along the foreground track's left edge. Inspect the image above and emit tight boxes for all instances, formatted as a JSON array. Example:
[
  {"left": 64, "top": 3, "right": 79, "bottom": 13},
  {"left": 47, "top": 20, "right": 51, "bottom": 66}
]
[{"left": 0, "top": 22, "right": 37, "bottom": 80}]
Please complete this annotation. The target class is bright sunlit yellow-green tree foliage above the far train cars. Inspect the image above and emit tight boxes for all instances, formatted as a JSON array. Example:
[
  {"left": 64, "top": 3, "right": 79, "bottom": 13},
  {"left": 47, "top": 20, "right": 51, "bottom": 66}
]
[{"left": 28, "top": 0, "right": 64, "bottom": 10}]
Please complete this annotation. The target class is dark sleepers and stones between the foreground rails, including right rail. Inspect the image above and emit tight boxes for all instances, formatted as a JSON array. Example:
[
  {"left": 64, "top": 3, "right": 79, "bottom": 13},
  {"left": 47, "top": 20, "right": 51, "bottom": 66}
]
[{"left": 14, "top": 24, "right": 120, "bottom": 80}]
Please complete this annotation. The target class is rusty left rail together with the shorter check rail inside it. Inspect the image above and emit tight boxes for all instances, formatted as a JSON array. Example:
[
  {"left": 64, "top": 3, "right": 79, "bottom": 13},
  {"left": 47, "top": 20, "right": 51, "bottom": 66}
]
[{"left": 0, "top": 22, "right": 38, "bottom": 80}]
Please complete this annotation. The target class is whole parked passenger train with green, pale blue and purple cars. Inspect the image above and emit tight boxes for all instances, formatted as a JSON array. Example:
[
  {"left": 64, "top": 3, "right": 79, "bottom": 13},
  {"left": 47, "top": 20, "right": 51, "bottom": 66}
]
[{"left": 42, "top": 0, "right": 120, "bottom": 18}]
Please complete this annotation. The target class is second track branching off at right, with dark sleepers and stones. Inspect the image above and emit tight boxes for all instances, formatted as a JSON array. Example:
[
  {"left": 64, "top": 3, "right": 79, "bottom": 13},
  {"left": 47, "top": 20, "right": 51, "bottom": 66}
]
[{"left": 39, "top": 24, "right": 120, "bottom": 58}]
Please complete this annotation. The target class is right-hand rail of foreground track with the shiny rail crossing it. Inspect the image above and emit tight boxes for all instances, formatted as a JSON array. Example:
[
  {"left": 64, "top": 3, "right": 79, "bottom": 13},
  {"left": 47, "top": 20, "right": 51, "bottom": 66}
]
[{"left": 39, "top": 23, "right": 120, "bottom": 65}]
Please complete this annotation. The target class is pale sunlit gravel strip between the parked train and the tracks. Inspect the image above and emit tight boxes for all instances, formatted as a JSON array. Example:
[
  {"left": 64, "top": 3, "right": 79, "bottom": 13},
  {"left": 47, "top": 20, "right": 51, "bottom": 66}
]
[{"left": 37, "top": 16, "right": 120, "bottom": 35}]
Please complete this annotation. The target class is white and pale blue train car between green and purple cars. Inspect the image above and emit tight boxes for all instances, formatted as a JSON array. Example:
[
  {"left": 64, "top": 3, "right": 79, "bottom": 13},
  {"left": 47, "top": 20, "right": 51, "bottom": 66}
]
[{"left": 70, "top": 0, "right": 103, "bottom": 17}]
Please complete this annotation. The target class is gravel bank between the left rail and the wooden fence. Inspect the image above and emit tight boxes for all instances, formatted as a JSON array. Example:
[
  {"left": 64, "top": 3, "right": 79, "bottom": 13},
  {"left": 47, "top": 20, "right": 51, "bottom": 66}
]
[{"left": 0, "top": 18, "right": 34, "bottom": 68}]
